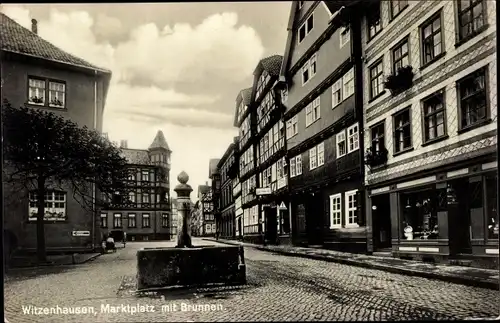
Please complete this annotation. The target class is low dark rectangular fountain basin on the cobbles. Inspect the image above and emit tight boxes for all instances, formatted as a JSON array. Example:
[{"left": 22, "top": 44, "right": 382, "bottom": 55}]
[{"left": 137, "top": 246, "right": 246, "bottom": 291}]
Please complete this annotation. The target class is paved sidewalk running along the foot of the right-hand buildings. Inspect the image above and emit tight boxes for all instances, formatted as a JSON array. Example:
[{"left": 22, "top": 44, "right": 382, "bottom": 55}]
[{"left": 203, "top": 238, "right": 500, "bottom": 290}]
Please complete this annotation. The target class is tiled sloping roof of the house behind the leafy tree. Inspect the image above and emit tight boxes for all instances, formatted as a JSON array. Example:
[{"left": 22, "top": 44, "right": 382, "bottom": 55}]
[{"left": 0, "top": 13, "right": 111, "bottom": 74}]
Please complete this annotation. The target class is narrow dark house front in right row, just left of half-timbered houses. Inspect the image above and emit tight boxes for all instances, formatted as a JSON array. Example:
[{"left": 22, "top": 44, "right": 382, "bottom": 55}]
[{"left": 216, "top": 137, "right": 238, "bottom": 239}]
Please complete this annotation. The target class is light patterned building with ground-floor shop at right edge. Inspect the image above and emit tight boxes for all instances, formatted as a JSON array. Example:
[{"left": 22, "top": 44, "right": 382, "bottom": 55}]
[{"left": 362, "top": 1, "right": 499, "bottom": 266}]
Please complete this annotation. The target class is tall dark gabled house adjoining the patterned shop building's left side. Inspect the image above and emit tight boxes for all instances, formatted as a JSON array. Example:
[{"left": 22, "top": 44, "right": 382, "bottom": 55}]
[{"left": 279, "top": 1, "right": 367, "bottom": 252}]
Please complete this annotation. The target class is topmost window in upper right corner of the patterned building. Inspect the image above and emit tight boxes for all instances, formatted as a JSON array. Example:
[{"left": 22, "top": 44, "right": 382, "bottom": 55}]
[{"left": 457, "top": 0, "right": 486, "bottom": 40}]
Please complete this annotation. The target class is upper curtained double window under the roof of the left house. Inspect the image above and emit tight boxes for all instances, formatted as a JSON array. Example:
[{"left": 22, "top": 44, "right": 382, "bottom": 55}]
[{"left": 28, "top": 77, "right": 66, "bottom": 108}]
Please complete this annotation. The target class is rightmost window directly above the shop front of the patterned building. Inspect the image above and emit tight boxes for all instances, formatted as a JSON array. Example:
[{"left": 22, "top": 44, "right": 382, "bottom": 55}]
[{"left": 457, "top": 68, "right": 488, "bottom": 129}]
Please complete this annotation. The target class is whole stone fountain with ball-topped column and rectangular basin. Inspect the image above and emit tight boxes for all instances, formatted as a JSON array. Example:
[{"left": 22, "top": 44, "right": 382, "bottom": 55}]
[{"left": 137, "top": 171, "right": 246, "bottom": 291}]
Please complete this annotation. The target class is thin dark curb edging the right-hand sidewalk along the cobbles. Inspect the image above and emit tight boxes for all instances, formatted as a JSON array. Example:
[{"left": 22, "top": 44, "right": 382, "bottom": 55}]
[{"left": 204, "top": 239, "right": 500, "bottom": 291}]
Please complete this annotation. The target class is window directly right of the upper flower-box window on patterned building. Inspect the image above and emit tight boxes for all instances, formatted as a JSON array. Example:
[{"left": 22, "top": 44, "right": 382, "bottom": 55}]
[{"left": 421, "top": 12, "right": 443, "bottom": 65}]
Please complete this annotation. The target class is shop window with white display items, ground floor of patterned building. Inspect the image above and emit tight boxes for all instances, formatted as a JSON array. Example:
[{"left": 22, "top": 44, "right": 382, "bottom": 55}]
[{"left": 400, "top": 188, "right": 439, "bottom": 240}]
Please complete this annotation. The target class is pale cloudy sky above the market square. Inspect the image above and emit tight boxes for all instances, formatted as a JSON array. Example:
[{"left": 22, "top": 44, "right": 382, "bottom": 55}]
[{"left": 2, "top": 1, "right": 291, "bottom": 198}]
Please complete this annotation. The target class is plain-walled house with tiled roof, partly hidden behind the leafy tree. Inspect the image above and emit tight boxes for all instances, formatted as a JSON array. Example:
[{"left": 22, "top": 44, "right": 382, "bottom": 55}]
[{"left": 0, "top": 13, "right": 111, "bottom": 253}]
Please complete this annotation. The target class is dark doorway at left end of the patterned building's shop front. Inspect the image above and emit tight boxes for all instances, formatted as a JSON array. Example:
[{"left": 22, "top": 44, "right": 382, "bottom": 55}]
[{"left": 371, "top": 194, "right": 392, "bottom": 251}]
